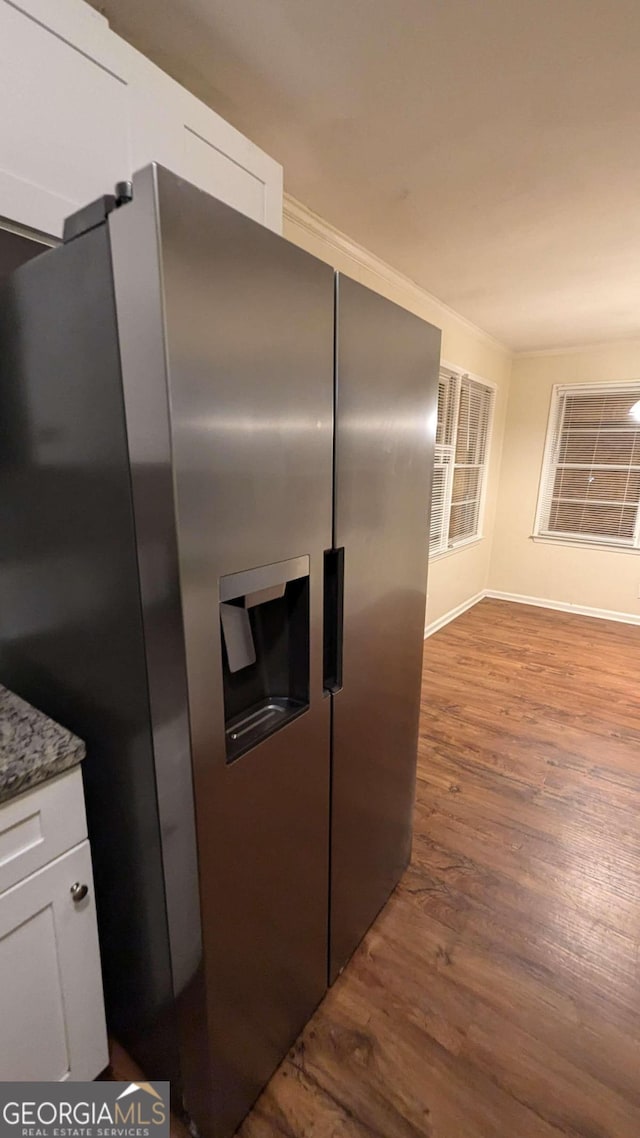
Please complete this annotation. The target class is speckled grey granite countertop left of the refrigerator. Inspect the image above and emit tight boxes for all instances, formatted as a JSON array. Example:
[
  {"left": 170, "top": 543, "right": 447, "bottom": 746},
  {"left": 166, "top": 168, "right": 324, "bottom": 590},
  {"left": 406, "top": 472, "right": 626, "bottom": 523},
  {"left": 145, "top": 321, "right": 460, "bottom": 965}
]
[{"left": 0, "top": 685, "right": 85, "bottom": 802}]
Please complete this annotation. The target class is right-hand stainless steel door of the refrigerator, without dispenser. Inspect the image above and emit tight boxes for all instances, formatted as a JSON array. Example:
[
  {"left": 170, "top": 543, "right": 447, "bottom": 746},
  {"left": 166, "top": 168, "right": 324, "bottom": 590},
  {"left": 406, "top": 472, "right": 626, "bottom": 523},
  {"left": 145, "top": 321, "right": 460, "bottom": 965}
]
[{"left": 329, "top": 275, "right": 440, "bottom": 981}]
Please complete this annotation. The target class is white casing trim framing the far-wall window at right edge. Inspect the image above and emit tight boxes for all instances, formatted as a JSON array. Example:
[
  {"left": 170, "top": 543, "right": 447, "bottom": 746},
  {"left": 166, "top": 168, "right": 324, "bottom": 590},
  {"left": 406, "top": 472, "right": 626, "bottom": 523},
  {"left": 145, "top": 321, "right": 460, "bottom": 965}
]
[{"left": 531, "top": 379, "right": 640, "bottom": 553}]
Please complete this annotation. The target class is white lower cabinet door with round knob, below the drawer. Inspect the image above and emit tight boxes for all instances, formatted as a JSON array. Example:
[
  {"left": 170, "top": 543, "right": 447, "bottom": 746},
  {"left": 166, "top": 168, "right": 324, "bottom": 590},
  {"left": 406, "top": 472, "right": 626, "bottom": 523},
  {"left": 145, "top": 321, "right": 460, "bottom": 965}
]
[{"left": 0, "top": 841, "right": 108, "bottom": 1082}]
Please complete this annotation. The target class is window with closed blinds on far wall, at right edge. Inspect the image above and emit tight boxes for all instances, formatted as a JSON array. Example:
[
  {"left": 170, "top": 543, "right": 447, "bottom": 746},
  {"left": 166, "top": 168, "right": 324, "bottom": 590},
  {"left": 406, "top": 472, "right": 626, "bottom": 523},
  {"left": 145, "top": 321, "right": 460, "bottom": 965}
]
[{"left": 534, "top": 382, "right": 640, "bottom": 549}]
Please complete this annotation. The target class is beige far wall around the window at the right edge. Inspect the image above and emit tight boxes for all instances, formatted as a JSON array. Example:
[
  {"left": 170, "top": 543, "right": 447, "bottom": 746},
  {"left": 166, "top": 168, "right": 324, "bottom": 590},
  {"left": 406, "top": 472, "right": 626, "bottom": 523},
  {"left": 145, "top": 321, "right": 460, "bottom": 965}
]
[{"left": 489, "top": 340, "right": 640, "bottom": 615}]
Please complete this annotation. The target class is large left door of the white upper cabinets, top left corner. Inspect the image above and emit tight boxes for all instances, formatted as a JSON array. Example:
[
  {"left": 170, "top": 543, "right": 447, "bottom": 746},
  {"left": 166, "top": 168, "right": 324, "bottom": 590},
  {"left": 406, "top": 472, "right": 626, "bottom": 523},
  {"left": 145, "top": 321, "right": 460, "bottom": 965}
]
[{"left": 0, "top": 0, "right": 131, "bottom": 237}]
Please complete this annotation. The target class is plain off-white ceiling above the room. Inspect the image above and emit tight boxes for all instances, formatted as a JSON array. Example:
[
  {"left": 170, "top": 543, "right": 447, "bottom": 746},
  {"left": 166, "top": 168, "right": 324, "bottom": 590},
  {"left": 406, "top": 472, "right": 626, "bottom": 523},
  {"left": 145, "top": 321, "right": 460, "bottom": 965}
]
[{"left": 88, "top": 0, "right": 640, "bottom": 351}]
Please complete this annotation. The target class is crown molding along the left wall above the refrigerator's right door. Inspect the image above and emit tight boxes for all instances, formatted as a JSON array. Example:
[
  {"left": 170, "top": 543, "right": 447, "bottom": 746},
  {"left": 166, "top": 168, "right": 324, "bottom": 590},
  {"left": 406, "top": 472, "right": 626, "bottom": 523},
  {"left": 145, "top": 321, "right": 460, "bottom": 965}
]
[{"left": 282, "top": 193, "right": 512, "bottom": 357}]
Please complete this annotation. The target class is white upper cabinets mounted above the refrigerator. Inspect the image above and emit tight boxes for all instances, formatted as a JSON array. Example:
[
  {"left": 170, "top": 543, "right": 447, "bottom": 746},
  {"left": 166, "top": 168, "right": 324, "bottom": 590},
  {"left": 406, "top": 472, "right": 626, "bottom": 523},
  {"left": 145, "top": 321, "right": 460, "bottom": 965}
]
[{"left": 0, "top": 0, "right": 282, "bottom": 237}]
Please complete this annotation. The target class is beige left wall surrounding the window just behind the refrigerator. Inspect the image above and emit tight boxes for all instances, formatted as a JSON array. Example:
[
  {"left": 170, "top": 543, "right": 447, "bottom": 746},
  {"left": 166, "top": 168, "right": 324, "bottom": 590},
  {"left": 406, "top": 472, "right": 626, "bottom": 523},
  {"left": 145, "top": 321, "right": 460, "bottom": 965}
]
[{"left": 284, "top": 206, "right": 511, "bottom": 624}]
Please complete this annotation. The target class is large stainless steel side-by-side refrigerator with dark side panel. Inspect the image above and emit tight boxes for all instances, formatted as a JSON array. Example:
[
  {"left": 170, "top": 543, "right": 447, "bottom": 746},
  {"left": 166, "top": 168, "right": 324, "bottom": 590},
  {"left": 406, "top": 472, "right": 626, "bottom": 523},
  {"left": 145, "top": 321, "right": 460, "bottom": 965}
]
[{"left": 0, "top": 166, "right": 440, "bottom": 1138}]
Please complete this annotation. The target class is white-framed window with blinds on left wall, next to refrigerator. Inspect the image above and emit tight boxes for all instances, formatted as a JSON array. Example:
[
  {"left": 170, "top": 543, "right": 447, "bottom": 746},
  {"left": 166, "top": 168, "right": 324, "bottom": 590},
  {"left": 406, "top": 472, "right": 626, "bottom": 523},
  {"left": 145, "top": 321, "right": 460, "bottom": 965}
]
[{"left": 429, "top": 369, "right": 493, "bottom": 556}]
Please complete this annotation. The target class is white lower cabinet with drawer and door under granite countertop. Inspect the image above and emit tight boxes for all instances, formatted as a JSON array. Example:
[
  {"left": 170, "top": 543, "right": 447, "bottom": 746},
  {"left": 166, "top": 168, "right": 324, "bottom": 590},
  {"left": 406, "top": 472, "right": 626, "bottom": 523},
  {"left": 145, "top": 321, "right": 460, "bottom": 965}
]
[{"left": 0, "top": 767, "right": 108, "bottom": 1081}]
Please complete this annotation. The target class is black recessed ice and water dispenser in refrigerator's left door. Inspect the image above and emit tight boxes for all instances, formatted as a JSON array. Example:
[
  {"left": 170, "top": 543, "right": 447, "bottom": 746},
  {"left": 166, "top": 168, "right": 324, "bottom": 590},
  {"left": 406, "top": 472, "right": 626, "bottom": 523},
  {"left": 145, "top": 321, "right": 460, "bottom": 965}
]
[{"left": 220, "top": 556, "right": 309, "bottom": 762}]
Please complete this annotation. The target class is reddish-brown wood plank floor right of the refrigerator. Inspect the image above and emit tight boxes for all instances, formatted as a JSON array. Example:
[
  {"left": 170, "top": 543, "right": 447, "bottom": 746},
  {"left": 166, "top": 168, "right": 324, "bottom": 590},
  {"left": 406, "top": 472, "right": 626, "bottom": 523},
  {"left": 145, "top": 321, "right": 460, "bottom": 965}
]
[{"left": 239, "top": 601, "right": 640, "bottom": 1138}]
